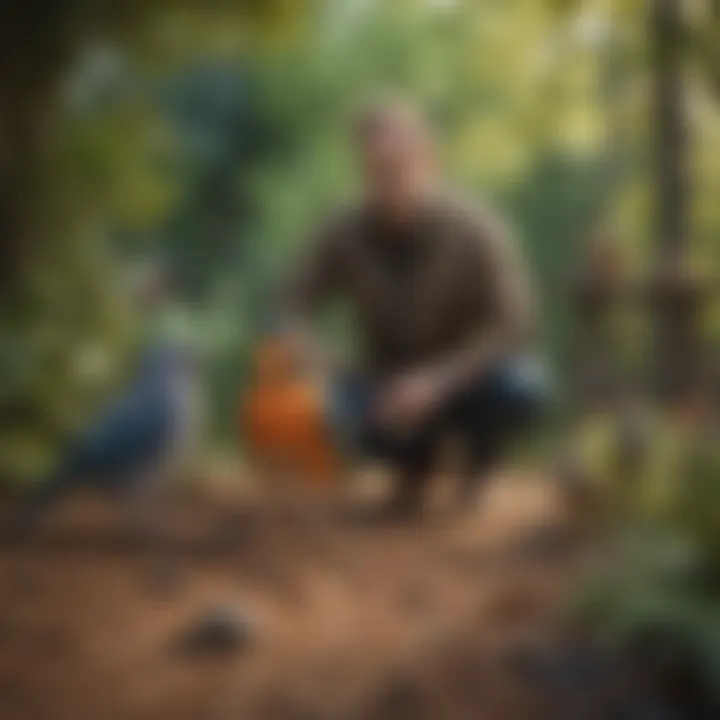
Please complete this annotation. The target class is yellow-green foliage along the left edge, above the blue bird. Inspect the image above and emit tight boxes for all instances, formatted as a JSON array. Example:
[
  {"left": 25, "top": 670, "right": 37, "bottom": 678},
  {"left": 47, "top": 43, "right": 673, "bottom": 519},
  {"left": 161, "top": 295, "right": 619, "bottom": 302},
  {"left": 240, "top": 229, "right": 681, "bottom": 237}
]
[{"left": 0, "top": 0, "right": 306, "bottom": 481}]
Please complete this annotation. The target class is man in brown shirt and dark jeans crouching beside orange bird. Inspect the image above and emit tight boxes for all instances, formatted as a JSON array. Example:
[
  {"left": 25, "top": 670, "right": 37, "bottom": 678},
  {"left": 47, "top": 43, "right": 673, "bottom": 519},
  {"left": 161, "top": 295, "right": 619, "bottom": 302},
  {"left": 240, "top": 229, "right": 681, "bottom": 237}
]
[{"left": 289, "top": 103, "right": 541, "bottom": 514}]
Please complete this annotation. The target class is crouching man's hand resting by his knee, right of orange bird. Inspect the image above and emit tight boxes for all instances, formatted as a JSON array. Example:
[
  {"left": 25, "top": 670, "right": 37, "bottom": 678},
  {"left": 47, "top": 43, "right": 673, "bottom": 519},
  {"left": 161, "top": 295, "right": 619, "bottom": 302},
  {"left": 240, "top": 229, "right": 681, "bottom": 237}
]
[{"left": 374, "top": 370, "right": 448, "bottom": 429}]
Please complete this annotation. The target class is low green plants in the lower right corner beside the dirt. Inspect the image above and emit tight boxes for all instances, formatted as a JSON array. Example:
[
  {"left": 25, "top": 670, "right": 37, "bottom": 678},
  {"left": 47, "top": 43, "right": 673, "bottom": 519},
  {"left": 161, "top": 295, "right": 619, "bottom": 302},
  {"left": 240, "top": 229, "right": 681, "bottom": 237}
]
[{"left": 572, "top": 418, "right": 720, "bottom": 697}]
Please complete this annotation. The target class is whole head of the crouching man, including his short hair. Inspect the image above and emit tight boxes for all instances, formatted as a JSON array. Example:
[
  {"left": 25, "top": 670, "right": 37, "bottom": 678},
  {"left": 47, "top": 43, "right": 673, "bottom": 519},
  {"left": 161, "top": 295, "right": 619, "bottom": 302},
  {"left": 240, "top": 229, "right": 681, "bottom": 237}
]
[{"left": 357, "top": 101, "right": 435, "bottom": 219}]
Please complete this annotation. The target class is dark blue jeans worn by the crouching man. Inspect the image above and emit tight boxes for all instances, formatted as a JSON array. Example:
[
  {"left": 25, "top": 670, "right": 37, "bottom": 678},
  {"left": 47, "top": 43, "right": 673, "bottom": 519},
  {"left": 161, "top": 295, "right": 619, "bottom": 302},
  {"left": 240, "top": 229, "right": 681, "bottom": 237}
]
[{"left": 335, "top": 359, "right": 549, "bottom": 490}]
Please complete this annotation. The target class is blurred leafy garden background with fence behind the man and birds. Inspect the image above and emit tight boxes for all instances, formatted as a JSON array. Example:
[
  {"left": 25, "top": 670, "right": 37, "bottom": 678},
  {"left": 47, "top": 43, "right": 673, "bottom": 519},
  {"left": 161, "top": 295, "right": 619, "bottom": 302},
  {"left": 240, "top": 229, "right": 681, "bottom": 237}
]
[{"left": 0, "top": 0, "right": 720, "bottom": 720}]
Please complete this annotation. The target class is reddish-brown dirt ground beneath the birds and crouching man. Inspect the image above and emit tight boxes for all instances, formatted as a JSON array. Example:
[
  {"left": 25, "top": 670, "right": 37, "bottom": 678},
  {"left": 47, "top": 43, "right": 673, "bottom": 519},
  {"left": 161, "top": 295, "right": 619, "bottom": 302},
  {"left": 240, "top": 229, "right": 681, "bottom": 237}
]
[{"left": 0, "top": 473, "right": 579, "bottom": 720}]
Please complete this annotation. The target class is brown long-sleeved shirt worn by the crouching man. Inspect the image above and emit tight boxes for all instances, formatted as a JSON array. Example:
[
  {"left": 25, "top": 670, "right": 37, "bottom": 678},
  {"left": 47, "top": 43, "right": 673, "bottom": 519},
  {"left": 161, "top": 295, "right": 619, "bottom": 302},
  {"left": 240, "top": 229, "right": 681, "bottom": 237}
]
[{"left": 290, "top": 191, "right": 533, "bottom": 373}]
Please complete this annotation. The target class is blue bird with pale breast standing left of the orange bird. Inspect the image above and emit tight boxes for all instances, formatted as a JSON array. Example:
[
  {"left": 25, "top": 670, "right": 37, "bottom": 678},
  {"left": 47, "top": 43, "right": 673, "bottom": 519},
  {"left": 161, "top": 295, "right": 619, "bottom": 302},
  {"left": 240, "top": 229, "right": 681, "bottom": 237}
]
[{"left": 12, "top": 343, "right": 199, "bottom": 537}]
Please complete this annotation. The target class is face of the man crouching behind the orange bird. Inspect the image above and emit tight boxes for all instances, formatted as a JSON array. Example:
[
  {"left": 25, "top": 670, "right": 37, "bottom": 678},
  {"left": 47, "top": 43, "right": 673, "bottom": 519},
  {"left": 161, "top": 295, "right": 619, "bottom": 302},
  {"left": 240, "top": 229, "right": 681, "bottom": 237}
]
[{"left": 360, "top": 117, "right": 432, "bottom": 217}]
